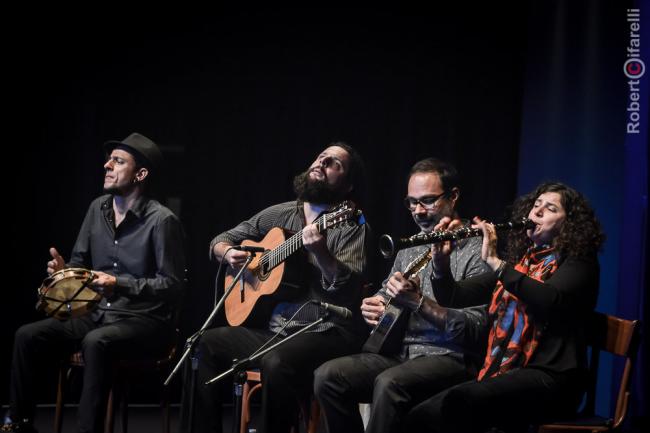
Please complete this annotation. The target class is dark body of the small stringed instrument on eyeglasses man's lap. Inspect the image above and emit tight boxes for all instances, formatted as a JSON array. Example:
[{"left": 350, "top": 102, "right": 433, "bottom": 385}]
[{"left": 362, "top": 303, "right": 410, "bottom": 355}]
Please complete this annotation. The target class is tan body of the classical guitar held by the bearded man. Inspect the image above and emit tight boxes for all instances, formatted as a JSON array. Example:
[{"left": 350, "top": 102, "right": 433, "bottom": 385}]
[{"left": 225, "top": 227, "right": 305, "bottom": 327}]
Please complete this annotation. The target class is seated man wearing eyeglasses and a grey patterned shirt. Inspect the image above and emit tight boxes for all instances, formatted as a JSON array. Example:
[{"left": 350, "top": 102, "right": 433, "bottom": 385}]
[{"left": 314, "top": 158, "right": 489, "bottom": 433}]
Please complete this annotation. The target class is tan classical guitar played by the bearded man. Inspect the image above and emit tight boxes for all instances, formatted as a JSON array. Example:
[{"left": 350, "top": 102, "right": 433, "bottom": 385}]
[{"left": 225, "top": 201, "right": 361, "bottom": 326}]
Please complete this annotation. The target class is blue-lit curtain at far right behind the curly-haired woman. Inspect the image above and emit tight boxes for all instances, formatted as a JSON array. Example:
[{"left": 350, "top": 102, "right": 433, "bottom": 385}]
[{"left": 518, "top": 1, "right": 650, "bottom": 431}]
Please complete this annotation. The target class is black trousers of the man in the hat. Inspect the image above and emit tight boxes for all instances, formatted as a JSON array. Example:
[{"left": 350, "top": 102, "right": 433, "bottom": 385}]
[{"left": 10, "top": 316, "right": 171, "bottom": 433}]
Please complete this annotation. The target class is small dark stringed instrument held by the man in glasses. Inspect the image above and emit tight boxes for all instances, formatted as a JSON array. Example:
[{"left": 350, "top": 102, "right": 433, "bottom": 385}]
[{"left": 362, "top": 249, "right": 431, "bottom": 355}]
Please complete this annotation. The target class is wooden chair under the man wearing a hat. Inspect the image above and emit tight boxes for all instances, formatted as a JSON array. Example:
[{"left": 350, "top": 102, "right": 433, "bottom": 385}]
[{"left": 54, "top": 329, "right": 179, "bottom": 433}]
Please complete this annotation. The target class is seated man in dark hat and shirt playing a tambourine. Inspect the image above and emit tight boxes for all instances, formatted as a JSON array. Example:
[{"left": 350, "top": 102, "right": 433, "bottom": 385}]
[{"left": 1, "top": 133, "right": 185, "bottom": 433}]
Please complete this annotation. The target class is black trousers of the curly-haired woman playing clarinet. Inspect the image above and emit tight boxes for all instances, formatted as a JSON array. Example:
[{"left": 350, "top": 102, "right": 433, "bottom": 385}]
[{"left": 404, "top": 368, "right": 582, "bottom": 433}]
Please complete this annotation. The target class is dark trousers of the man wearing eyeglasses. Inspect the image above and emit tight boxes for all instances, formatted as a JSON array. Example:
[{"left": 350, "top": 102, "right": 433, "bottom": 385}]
[{"left": 314, "top": 353, "right": 470, "bottom": 433}]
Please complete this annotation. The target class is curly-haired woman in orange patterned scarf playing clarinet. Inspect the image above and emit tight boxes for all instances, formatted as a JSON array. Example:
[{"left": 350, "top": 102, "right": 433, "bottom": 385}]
[{"left": 402, "top": 183, "right": 604, "bottom": 433}]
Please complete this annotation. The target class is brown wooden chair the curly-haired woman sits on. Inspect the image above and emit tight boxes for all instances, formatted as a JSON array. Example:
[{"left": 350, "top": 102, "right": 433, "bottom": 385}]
[{"left": 538, "top": 313, "right": 640, "bottom": 433}]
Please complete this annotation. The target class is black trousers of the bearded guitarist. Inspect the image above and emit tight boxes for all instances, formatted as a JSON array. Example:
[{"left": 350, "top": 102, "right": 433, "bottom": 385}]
[{"left": 190, "top": 327, "right": 362, "bottom": 433}]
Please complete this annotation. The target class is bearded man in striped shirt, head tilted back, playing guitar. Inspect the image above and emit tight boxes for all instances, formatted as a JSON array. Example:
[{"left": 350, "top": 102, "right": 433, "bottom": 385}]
[{"left": 189, "top": 142, "right": 369, "bottom": 433}]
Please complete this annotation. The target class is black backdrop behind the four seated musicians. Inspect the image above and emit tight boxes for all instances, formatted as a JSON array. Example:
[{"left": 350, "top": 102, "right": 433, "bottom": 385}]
[{"left": 0, "top": 1, "right": 650, "bottom": 430}]
